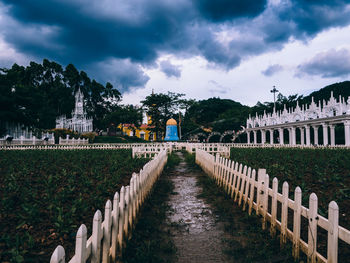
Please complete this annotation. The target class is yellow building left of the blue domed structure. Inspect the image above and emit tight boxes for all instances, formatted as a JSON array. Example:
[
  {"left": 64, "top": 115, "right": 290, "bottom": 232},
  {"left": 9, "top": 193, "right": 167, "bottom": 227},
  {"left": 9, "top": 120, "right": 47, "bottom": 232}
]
[{"left": 118, "top": 116, "right": 157, "bottom": 141}]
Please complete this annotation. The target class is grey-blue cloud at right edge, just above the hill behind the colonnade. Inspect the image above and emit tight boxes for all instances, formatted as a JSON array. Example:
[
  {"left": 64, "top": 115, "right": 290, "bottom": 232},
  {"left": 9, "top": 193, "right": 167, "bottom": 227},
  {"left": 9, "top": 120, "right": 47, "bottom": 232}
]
[{"left": 296, "top": 49, "right": 350, "bottom": 78}]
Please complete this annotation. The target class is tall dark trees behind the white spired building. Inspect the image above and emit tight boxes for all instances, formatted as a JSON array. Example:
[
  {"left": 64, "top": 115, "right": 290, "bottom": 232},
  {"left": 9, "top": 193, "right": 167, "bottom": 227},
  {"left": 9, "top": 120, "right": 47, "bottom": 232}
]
[{"left": 0, "top": 59, "right": 121, "bottom": 129}]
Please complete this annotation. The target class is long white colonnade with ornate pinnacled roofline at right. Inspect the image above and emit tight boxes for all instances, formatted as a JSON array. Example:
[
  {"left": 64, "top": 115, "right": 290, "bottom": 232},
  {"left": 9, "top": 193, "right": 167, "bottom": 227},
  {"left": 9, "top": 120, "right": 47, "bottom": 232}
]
[{"left": 246, "top": 92, "right": 350, "bottom": 146}]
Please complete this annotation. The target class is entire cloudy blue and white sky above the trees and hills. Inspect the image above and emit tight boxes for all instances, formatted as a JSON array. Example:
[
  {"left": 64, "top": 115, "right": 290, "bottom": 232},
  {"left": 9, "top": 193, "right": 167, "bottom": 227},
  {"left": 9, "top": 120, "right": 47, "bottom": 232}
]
[{"left": 0, "top": 0, "right": 350, "bottom": 105}]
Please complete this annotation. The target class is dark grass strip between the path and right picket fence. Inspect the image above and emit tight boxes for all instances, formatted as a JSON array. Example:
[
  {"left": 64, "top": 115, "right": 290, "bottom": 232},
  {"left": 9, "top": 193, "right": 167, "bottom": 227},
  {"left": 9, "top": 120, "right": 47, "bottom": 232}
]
[{"left": 185, "top": 154, "right": 304, "bottom": 263}]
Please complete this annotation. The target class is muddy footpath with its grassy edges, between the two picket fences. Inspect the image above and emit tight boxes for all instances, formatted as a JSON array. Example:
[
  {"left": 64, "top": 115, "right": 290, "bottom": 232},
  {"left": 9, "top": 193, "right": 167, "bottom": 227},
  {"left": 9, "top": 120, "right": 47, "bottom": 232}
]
[{"left": 123, "top": 152, "right": 294, "bottom": 263}]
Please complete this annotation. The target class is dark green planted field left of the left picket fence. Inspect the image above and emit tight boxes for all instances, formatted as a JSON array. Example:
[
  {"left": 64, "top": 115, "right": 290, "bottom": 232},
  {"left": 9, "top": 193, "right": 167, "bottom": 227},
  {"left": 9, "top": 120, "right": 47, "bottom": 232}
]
[{"left": 0, "top": 150, "right": 147, "bottom": 262}]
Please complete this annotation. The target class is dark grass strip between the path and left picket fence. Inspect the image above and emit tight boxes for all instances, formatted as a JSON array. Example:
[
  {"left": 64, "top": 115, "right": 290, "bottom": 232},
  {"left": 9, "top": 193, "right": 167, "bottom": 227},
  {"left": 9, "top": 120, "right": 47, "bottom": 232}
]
[{"left": 123, "top": 154, "right": 180, "bottom": 263}]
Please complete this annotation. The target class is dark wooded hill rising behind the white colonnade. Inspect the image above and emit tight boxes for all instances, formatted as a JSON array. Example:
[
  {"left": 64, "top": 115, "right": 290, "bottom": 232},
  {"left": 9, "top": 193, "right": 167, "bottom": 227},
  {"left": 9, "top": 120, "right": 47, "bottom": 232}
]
[{"left": 182, "top": 81, "right": 350, "bottom": 139}]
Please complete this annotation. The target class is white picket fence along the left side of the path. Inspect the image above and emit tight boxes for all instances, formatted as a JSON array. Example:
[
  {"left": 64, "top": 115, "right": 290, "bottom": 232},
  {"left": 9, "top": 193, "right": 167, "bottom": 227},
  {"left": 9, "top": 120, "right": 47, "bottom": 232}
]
[{"left": 50, "top": 151, "right": 168, "bottom": 263}]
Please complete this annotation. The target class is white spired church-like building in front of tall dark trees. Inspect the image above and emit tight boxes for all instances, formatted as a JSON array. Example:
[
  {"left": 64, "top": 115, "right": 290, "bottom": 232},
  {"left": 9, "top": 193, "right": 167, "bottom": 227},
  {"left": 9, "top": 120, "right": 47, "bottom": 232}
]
[{"left": 56, "top": 89, "right": 93, "bottom": 133}]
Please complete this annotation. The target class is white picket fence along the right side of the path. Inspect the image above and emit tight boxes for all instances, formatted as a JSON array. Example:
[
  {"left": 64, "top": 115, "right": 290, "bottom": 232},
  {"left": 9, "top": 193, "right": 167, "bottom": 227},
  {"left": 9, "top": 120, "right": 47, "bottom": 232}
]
[{"left": 196, "top": 149, "right": 350, "bottom": 263}]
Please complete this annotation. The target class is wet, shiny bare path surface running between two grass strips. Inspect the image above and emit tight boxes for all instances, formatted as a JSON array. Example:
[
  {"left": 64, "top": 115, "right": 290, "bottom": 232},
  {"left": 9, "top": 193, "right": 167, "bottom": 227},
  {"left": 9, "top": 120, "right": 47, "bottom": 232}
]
[{"left": 167, "top": 152, "right": 230, "bottom": 263}]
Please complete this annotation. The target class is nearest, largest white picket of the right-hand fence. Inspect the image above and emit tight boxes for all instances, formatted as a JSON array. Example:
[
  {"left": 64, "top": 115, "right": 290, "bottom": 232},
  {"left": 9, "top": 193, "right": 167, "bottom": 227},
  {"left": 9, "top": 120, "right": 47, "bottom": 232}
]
[{"left": 327, "top": 201, "right": 339, "bottom": 263}]
